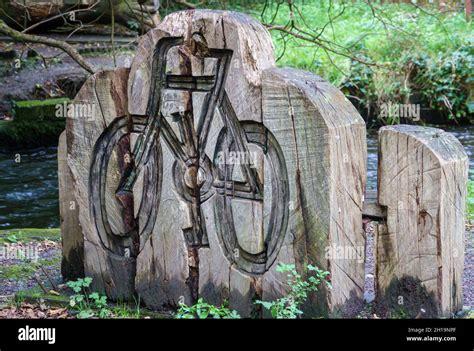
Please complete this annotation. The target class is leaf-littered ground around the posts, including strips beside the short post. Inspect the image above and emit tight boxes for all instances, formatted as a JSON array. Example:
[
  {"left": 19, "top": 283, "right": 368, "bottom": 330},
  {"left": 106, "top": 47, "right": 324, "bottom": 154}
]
[{"left": 0, "top": 227, "right": 474, "bottom": 318}]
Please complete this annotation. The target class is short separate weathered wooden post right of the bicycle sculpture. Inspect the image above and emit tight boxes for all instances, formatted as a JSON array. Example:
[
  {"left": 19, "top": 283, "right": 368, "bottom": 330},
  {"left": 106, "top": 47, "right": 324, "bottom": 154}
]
[{"left": 376, "top": 125, "right": 468, "bottom": 317}]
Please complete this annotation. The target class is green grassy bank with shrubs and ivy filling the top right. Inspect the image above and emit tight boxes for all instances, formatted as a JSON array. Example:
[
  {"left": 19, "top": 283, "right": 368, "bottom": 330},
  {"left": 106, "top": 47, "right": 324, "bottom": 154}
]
[{"left": 224, "top": 0, "right": 474, "bottom": 124}]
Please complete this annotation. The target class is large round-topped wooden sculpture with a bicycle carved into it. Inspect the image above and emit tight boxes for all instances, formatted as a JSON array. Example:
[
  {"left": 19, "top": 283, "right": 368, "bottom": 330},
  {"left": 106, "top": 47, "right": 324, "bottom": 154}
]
[{"left": 63, "top": 11, "right": 365, "bottom": 315}]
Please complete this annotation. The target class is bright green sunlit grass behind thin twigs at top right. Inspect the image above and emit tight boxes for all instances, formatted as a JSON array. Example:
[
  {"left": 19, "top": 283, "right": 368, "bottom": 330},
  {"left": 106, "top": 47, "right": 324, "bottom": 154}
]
[{"left": 258, "top": 1, "right": 472, "bottom": 80}]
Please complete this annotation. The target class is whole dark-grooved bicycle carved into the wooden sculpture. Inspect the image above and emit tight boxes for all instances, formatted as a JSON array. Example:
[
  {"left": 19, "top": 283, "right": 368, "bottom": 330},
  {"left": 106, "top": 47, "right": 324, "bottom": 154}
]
[{"left": 89, "top": 33, "right": 289, "bottom": 274}]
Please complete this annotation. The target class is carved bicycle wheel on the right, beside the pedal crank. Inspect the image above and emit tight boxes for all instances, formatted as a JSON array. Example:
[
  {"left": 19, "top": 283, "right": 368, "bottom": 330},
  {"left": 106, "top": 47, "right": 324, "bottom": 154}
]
[{"left": 214, "top": 122, "right": 289, "bottom": 274}]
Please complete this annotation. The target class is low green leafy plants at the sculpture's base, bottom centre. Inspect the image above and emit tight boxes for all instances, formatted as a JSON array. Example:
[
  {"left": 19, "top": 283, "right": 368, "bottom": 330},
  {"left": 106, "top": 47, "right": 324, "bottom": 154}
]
[{"left": 175, "top": 299, "right": 240, "bottom": 319}]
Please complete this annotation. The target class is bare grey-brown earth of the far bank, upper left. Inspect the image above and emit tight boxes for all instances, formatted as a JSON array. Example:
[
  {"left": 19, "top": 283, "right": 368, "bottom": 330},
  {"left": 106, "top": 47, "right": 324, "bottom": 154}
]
[{"left": 0, "top": 34, "right": 136, "bottom": 119}]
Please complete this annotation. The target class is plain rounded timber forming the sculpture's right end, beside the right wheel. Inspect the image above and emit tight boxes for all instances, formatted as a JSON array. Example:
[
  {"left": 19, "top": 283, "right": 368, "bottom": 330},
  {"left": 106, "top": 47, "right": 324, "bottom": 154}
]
[{"left": 263, "top": 69, "right": 366, "bottom": 316}]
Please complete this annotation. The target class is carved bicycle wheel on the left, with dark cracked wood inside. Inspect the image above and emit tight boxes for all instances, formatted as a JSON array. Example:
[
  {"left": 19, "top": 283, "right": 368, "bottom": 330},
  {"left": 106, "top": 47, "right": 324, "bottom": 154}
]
[{"left": 89, "top": 117, "right": 162, "bottom": 257}]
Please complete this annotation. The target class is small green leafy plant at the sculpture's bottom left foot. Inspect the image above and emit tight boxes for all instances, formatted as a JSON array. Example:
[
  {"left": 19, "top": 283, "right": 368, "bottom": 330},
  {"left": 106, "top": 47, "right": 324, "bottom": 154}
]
[{"left": 67, "top": 277, "right": 111, "bottom": 319}]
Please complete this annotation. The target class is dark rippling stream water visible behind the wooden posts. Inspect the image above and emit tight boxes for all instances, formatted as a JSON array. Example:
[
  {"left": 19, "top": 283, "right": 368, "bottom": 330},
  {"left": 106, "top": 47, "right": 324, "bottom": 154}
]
[{"left": 0, "top": 126, "right": 474, "bottom": 229}]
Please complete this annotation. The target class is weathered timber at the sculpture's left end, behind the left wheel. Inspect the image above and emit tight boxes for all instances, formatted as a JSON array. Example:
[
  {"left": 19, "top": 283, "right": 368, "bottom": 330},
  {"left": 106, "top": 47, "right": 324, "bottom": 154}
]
[{"left": 66, "top": 69, "right": 135, "bottom": 298}]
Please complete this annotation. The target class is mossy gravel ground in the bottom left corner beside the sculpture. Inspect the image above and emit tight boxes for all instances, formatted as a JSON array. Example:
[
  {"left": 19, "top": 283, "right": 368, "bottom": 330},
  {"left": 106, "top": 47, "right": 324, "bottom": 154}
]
[{"left": 0, "top": 229, "right": 69, "bottom": 318}]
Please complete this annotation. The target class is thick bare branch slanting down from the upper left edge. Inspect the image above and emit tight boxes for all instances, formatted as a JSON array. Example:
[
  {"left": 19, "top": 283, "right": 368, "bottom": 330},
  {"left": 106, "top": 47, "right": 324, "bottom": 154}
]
[{"left": 0, "top": 20, "right": 95, "bottom": 74}]
